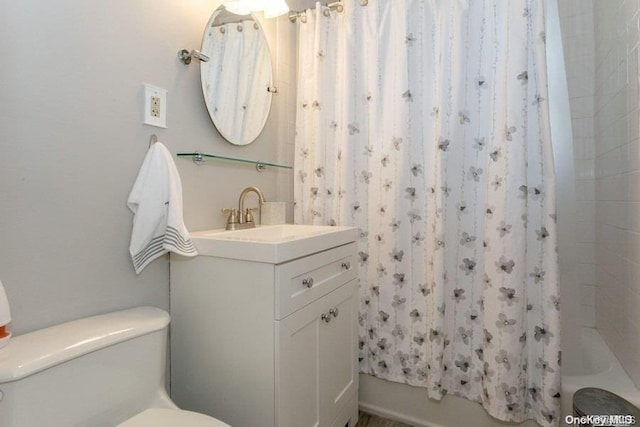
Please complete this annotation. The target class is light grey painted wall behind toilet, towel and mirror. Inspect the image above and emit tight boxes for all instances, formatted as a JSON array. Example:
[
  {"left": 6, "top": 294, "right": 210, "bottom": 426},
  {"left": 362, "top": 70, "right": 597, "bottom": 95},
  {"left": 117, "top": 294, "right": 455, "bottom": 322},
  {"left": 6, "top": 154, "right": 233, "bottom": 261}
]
[{"left": 0, "top": 0, "right": 295, "bottom": 333}]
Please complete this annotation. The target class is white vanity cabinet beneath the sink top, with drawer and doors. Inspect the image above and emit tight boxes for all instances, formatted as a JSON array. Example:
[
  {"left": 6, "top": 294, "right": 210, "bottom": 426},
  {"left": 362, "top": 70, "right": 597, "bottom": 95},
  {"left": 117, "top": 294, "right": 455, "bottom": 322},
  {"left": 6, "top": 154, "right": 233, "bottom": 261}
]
[{"left": 171, "top": 229, "right": 358, "bottom": 427}]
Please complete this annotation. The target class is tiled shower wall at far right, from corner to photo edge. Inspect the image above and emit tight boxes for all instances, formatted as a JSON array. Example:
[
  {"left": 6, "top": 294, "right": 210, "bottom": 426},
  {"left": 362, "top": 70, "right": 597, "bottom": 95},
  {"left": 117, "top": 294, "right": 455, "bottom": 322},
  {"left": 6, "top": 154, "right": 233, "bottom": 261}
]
[{"left": 593, "top": 0, "right": 640, "bottom": 386}]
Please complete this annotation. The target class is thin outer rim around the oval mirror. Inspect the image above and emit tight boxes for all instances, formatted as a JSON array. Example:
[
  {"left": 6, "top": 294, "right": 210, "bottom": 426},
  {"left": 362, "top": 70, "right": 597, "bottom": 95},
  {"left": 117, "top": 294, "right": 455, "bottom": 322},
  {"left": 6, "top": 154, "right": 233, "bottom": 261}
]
[{"left": 200, "top": 5, "right": 275, "bottom": 146}]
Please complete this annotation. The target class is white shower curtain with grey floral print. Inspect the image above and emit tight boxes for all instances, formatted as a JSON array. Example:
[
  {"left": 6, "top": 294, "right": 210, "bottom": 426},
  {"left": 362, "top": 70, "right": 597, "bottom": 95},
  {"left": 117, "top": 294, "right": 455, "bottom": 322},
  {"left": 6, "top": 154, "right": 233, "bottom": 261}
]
[{"left": 294, "top": 0, "right": 560, "bottom": 425}]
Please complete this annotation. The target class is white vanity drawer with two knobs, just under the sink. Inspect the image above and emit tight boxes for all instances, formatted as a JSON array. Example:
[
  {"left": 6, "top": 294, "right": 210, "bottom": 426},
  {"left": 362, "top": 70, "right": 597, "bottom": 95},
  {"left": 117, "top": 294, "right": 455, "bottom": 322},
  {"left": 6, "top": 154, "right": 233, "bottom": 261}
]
[{"left": 275, "top": 243, "right": 357, "bottom": 320}]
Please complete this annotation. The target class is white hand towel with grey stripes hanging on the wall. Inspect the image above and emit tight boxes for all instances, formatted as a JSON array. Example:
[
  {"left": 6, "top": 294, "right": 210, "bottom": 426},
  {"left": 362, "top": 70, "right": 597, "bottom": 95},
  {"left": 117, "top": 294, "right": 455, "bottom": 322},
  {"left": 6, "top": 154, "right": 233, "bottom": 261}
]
[{"left": 127, "top": 142, "right": 198, "bottom": 274}]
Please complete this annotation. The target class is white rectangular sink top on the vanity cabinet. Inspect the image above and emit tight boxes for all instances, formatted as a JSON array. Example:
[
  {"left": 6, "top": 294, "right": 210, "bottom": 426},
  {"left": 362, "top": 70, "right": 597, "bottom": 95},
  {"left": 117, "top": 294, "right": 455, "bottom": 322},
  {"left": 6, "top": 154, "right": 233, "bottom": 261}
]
[{"left": 191, "top": 224, "right": 358, "bottom": 264}]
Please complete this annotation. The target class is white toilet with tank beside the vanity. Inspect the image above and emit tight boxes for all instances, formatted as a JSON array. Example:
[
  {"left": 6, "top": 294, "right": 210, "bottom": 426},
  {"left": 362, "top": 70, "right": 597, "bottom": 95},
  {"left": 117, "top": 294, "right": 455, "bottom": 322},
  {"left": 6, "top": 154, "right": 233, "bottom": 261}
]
[{"left": 0, "top": 307, "right": 229, "bottom": 427}]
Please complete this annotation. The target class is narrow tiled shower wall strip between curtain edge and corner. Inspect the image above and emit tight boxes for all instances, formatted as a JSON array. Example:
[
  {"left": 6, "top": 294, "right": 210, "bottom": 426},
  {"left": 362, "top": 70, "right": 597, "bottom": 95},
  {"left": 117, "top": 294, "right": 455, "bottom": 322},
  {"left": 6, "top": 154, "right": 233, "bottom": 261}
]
[{"left": 558, "top": 0, "right": 596, "bottom": 327}]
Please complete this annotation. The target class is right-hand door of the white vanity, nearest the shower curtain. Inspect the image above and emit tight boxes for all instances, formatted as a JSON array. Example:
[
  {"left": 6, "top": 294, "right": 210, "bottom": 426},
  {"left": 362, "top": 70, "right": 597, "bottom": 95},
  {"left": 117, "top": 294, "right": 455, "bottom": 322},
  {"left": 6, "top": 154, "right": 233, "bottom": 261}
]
[{"left": 320, "top": 280, "right": 358, "bottom": 426}]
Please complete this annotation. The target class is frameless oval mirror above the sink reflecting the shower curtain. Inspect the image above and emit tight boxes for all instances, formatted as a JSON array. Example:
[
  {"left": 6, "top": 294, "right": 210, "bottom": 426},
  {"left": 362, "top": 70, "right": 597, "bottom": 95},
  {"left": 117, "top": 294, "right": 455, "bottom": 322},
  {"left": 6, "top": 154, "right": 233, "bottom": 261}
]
[{"left": 200, "top": 6, "right": 272, "bottom": 145}]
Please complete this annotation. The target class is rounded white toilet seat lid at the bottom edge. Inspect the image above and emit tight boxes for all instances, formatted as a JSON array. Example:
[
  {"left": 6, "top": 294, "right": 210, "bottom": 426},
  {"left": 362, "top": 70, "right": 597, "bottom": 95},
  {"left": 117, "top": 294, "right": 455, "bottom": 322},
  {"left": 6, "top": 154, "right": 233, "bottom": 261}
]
[{"left": 118, "top": 408, "right": 231, "bottom": 427}]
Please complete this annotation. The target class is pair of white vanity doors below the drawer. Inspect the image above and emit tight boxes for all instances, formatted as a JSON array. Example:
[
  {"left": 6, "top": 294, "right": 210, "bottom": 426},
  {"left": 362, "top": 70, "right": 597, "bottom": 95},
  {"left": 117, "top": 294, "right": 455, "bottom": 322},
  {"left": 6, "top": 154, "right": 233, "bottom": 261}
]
[{"left": 276, "top": 280, "right": 357, "bottom": 427}]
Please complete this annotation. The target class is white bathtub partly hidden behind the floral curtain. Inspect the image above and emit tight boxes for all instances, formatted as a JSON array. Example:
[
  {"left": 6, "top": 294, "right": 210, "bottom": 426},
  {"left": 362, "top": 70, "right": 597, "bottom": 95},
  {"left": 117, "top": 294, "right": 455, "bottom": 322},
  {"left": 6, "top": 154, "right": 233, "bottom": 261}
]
[{"left": 359, "top": 328, "right": 640, "bottom": 427}]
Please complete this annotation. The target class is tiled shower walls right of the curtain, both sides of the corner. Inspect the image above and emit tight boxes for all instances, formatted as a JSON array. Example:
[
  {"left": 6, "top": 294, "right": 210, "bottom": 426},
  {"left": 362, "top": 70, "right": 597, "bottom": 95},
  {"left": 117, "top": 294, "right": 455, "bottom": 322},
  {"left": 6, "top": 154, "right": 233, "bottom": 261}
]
[{"left": 558, "top": 0, "right": 640, "bottom": 392}]
